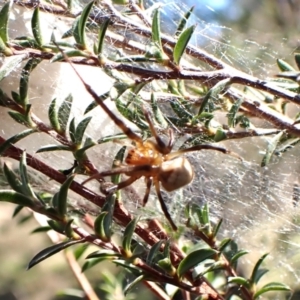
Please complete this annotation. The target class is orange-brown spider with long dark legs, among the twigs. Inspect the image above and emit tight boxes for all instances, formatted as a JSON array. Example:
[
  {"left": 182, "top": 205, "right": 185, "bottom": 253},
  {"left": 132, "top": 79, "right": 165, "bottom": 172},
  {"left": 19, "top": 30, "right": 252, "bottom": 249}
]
[{"left": 64, "top": 55, "right": 241, "bottom": 231}]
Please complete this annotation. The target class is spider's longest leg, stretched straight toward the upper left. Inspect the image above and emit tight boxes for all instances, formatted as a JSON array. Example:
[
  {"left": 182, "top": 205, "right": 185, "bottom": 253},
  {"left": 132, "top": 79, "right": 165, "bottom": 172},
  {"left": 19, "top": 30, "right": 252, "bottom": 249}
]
[{"left": 56, "top": 45, "right": 143, "bottom": 143}]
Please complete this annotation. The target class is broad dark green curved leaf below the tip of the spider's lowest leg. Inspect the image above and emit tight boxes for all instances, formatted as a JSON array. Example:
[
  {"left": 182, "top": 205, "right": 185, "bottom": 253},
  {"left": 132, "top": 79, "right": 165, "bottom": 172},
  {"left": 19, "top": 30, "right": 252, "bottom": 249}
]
[{"left": 177, "top": 249, "right": 219, "bottom": 277}]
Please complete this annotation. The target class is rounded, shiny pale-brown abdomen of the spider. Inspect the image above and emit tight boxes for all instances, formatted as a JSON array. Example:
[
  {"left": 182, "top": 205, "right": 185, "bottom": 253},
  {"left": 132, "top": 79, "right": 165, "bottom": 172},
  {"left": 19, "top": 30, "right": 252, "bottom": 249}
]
[{"left": 158, "top": 157, "right": 194, "bottom": 192}]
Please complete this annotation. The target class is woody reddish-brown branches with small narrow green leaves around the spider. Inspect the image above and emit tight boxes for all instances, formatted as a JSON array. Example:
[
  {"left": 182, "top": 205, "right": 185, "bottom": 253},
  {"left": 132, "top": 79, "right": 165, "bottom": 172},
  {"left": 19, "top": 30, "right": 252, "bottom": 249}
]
[{"left": 0, "top": 0, "right": 300, "bottom": 300}]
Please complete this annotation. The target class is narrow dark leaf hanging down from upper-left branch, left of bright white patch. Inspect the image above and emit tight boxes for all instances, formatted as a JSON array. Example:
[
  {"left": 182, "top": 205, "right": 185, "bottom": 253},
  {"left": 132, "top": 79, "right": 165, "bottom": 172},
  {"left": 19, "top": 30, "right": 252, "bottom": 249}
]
[{"left": 19, "top": 58, "right": 42, "bottom": 108}]
